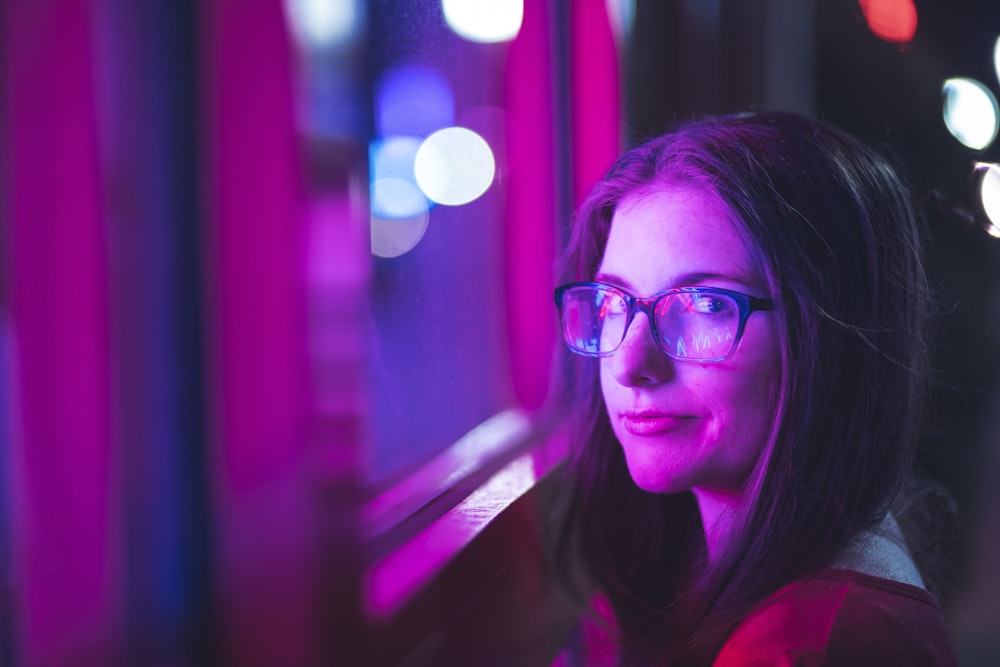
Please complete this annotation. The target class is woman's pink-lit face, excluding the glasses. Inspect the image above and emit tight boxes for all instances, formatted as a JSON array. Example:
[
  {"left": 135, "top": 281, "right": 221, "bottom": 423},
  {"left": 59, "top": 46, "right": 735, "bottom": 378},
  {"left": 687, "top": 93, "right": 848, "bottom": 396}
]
[{"left": 595, "top": 186, "right": 781, "bottom": 494}]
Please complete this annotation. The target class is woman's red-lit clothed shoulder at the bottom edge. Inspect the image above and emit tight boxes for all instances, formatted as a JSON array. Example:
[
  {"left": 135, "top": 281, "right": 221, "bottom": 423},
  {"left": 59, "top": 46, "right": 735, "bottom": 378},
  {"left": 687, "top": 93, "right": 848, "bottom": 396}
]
[{"left": 714, "top": 570, "right": 956, "bottom": 667}]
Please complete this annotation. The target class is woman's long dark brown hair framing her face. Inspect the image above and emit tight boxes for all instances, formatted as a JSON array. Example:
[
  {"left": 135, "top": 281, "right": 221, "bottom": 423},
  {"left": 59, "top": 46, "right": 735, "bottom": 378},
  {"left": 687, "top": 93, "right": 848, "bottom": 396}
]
[{"left": 562, "top": 112, "right": 928, "bottom": 664}]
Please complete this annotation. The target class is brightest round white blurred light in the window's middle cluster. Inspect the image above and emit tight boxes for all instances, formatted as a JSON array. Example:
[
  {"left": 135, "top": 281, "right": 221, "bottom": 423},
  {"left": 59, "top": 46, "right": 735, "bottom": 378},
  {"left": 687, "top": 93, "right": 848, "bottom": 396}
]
[{"left": 414, "top": 127, "right": 496, "bottom": 206}]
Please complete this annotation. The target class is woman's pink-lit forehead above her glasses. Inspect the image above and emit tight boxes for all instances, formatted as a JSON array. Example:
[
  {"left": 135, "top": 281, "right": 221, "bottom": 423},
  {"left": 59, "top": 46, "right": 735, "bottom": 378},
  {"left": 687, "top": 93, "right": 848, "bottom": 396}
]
[{"left": 598, "top": 185, "right": 764, "bottom": 293}]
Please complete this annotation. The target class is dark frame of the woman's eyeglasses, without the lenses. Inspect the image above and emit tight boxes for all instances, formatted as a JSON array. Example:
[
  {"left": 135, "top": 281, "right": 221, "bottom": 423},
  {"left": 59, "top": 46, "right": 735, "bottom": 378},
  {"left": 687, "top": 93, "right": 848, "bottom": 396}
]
[{"left": 553, "top": 282, "right": 775, "bottom": 363}]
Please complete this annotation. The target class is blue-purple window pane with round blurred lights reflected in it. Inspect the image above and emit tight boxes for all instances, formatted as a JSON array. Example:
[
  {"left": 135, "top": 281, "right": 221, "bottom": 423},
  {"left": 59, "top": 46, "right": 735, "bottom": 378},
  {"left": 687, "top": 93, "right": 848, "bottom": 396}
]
[{"left": 368, "top": 0, "right": 521, "bottom": 485}]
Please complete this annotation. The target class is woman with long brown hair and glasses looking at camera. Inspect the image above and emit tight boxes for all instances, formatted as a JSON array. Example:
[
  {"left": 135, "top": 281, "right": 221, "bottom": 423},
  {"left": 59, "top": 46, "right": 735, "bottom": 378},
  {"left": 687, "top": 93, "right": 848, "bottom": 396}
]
[{"left": 556, "top": 113, "right": 954, "bottom": 665}]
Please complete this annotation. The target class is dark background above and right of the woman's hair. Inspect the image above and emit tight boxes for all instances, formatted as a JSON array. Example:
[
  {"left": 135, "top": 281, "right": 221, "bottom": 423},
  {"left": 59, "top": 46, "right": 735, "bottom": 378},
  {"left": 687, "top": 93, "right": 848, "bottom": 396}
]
[{"left": 625, "top": 0, "right": 1000, "bottom": 632}]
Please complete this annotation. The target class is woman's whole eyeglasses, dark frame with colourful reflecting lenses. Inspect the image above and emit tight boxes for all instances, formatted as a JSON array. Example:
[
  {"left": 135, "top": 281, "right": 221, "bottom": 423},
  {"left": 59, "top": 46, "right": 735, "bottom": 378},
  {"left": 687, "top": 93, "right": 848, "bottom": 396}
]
[{"left": 555, "top": 283, "right": 774, "bottom": 362}]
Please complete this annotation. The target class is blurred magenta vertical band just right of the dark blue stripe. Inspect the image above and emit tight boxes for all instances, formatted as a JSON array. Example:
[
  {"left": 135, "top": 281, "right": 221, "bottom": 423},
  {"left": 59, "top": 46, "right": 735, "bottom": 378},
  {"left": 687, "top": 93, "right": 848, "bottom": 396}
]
[{"left": 200, "top": 0, "right": 363, "bottom": 666}]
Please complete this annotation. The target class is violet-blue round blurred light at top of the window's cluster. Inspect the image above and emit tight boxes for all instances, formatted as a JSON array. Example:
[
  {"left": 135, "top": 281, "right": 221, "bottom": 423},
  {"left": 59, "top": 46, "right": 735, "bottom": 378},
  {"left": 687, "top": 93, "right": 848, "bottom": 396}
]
[{"left": 375, "top": 65, "right": 455, "bottom": 137}]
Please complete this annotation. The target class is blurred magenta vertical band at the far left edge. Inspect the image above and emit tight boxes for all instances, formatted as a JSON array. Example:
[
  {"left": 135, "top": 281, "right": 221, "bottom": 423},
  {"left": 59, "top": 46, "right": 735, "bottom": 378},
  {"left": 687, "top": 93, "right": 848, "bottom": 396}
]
[{"left": 0, "top": 0, "right": 122, "bottom": 665}]
